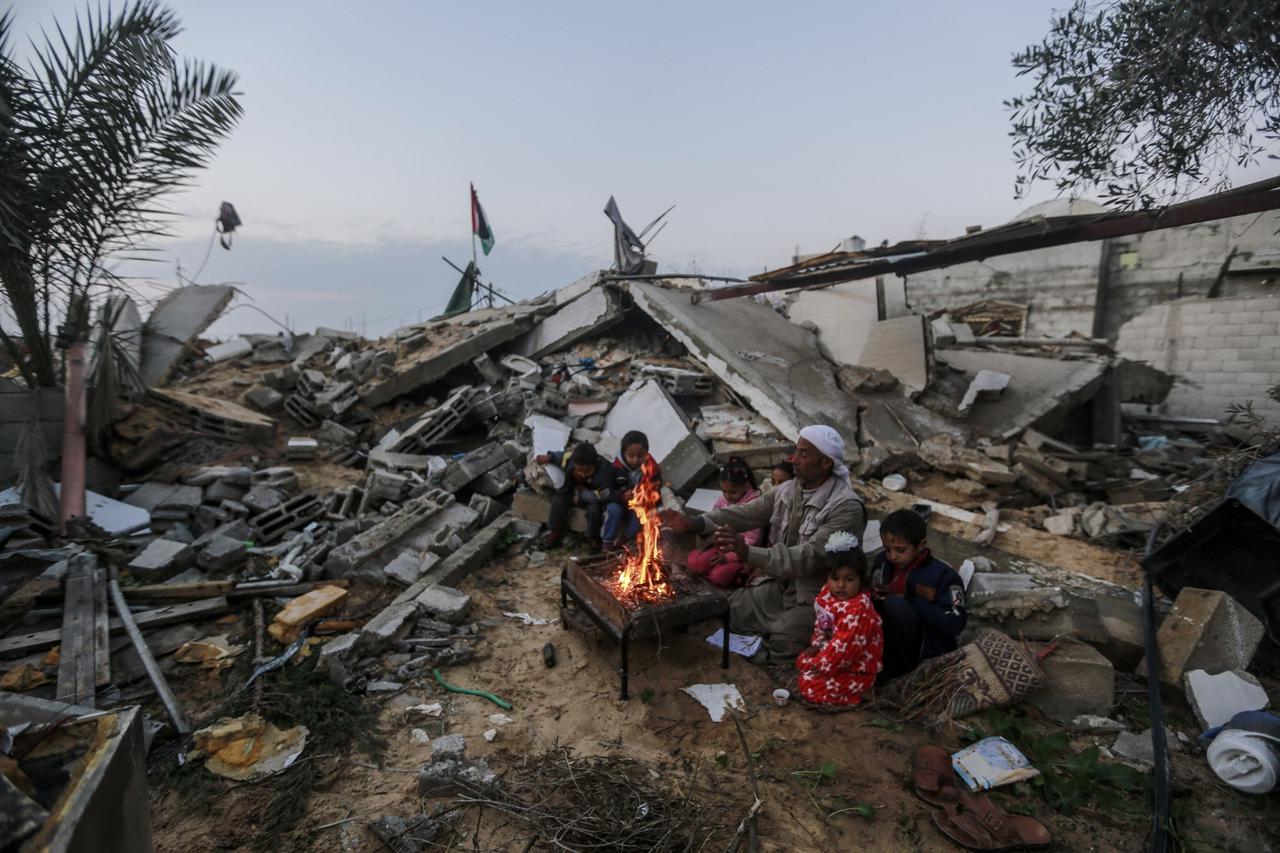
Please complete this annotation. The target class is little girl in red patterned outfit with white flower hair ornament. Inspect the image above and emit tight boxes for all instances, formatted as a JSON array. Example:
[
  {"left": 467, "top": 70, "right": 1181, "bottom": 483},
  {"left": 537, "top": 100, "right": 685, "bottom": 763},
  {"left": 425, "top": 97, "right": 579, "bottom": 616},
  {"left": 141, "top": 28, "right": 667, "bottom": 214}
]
[{"left": 796, "top": 530, "right": 884, "bottom": 708}]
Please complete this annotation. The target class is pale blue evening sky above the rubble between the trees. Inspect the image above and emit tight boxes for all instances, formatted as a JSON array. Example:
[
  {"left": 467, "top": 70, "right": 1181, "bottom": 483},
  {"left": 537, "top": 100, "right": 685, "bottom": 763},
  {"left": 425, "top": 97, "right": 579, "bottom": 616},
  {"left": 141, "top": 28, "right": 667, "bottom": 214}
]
[{"left": 15, "top": 0, "right": 1274, "bottom": 336}]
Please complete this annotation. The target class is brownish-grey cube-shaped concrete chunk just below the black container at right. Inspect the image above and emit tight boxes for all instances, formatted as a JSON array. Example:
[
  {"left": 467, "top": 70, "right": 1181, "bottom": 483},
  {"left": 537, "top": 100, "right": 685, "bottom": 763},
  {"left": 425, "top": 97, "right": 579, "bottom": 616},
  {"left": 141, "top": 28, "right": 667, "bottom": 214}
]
[{"left": 1138, "top": 587, "right": 1265, "bottom": 688}]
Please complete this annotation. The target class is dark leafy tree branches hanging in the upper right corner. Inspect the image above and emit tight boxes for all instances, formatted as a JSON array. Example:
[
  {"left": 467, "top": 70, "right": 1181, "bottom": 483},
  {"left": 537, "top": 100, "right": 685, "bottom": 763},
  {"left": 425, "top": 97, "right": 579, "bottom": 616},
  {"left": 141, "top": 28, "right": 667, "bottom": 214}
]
[{"left": 1005, "top": 0, "right": 1280, "bottom": 207}]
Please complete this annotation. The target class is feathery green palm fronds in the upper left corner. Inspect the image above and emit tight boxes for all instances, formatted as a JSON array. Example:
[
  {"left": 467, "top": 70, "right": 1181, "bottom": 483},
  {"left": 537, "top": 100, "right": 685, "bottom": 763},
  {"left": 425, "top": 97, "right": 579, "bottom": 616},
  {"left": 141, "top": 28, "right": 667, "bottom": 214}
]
[{"left": 0, "top": 0, "right": 242, "bottom": 387}]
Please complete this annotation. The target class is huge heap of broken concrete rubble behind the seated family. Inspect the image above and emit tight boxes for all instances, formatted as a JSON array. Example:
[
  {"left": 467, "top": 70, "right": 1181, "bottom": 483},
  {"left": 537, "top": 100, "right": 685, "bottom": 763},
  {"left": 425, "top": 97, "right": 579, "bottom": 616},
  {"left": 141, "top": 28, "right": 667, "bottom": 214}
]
[{"left": 0, "top": 263, "right": 1280, "bottom": 838}]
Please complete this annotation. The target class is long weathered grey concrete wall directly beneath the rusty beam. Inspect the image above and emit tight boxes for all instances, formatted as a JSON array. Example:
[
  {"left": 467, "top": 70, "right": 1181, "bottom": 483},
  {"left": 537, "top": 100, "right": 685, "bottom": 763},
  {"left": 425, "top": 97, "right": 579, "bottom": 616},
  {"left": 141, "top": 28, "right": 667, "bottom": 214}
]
[{"left": 906, "top": 211, "right": 1280, "bottom": 339}]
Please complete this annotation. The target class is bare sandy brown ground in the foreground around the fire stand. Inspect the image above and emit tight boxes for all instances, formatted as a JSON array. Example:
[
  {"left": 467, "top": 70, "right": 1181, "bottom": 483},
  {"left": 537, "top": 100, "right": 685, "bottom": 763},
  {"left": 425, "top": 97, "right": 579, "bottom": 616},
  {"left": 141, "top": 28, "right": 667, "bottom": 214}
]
[{"left": 142, "top": 545, "right": 1277, "bottom": 852}]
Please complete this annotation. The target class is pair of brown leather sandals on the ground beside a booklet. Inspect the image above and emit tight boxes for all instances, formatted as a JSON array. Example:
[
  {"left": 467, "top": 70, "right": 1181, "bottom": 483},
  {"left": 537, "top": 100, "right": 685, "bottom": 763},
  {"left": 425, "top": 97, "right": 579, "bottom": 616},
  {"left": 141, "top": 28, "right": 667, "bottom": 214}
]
[{"left": 913, "top": 744, "right": 1052, "bottom": 850}]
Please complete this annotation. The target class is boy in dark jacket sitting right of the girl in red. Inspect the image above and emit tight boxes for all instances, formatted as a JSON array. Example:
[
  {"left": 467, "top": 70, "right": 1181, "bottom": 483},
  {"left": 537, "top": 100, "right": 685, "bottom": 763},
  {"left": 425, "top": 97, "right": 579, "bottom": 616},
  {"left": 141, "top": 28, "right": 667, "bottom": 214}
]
[{"left": 872, "top": 510, "right": 969, "bottom": 681}]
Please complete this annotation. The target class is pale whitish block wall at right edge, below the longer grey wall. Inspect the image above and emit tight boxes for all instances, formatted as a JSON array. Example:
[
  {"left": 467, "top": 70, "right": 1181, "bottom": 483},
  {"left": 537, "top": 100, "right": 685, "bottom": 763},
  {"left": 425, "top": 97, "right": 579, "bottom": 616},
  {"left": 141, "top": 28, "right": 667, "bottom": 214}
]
[{"left": 1116, "top": 295, "right": 1280, "bottom": 425}]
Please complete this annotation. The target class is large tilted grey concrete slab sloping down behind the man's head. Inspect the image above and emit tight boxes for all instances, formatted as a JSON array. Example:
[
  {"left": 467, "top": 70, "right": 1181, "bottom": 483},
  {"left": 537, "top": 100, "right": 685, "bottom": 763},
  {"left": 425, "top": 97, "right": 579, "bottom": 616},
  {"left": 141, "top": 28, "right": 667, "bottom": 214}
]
[{"left": 628, "top": 282, "right": 858, "bottom": 461}]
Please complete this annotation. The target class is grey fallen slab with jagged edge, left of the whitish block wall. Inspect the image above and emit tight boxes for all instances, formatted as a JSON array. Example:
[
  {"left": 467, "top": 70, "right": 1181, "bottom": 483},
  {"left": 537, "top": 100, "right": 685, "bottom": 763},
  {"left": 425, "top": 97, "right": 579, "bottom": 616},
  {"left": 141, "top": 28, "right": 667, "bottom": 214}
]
[{"left": 938, "top": 350, "right": 1110, "bottom": 441}]
